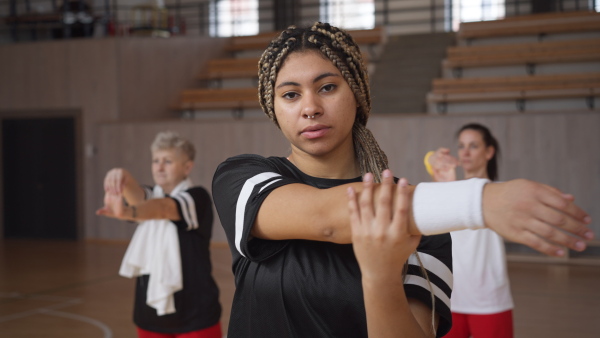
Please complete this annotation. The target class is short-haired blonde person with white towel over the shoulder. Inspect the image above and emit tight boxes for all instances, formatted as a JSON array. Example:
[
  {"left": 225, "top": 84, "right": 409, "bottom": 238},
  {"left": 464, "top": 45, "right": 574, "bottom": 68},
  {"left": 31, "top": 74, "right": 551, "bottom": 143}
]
[{"left": 96, "top": 132, "right": 222, "bottom": 338}]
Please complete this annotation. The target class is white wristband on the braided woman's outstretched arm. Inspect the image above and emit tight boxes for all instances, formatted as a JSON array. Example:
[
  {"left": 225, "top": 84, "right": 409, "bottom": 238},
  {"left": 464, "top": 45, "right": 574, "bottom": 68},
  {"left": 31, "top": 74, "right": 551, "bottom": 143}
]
[{"left": 413, "top": 178, "right": 490, "bottom": 235}]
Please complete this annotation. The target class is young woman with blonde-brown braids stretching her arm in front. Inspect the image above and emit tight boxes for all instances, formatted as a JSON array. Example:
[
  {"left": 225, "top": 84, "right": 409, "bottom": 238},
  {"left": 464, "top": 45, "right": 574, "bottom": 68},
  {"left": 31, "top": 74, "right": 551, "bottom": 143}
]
[{"left": 213, "top": 23, "right": 592, "bottom": 338}]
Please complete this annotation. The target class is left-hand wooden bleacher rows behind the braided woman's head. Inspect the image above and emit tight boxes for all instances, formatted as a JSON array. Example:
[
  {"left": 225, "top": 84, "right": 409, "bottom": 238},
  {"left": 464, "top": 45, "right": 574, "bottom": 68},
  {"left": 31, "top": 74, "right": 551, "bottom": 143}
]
[{"left": 172, "top": 27, "right": 385, "bottom": 117}]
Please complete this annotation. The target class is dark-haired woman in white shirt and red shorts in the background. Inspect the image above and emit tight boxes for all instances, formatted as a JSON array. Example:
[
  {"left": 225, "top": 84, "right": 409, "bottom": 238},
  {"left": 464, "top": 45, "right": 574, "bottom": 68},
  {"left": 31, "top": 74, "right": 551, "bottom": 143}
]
[{"left": 426, "top": 123, "right": 514, "bottom": 338}]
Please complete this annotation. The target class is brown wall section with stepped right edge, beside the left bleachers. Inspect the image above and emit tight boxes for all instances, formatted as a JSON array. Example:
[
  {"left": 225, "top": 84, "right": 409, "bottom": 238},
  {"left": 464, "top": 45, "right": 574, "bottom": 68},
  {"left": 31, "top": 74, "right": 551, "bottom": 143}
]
[{"left": 117, "top": 37, "right": 226, "bottom": 119}]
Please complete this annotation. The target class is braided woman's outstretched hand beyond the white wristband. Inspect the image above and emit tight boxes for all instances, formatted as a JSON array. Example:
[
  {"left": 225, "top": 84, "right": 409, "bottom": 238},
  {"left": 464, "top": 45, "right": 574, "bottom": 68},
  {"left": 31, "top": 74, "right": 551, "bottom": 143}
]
[{"left": 483, "top": 179, "right": 594, "bottom": 256}]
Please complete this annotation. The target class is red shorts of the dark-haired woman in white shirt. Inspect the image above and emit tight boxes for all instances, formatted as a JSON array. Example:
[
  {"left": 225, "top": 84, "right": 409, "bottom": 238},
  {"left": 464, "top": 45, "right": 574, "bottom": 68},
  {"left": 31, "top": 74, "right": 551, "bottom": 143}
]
[{"left": 444, "top": 310, "right": 514, "bottom": 338}]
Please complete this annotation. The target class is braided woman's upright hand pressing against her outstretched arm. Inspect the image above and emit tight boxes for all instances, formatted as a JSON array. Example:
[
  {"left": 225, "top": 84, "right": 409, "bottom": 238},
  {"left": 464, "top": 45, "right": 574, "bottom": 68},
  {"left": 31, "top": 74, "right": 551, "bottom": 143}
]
[{"left": 348, "top": 170, "right": 421, "bottom": 283}]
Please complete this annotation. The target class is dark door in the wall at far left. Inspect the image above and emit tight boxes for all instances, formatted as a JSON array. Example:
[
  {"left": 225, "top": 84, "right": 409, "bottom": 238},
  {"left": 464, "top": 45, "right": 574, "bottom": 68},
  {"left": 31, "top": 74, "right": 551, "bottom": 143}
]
[{"left": 2, "top": 117, "right": 77, "bottom": 239}]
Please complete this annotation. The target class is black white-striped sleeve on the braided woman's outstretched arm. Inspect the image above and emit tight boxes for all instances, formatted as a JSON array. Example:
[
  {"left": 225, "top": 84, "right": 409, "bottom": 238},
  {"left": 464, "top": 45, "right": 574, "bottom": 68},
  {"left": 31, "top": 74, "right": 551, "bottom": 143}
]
[{"left": 212, "top": 155, "right": 300, "bottom": 261}]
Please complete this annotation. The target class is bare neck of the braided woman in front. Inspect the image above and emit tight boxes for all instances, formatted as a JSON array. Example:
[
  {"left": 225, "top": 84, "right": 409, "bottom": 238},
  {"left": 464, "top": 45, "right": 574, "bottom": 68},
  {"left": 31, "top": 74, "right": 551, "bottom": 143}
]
[{"left": 288, "top": 145, "right": 360, "bottom": 179}]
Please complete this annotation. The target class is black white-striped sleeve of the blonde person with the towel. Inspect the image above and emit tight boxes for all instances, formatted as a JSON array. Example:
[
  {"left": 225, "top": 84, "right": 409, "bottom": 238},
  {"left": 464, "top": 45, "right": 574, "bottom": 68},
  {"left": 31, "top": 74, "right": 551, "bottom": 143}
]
[{"left": 169, "top": 187, "right": 213, "bottom": 237}]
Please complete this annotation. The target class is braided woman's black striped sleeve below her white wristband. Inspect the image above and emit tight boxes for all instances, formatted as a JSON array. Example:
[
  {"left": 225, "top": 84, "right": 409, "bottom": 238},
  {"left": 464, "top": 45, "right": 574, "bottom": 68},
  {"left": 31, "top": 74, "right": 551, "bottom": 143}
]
[{"left": 404, "top": 234, "right": 453, "bottom": 337}]
